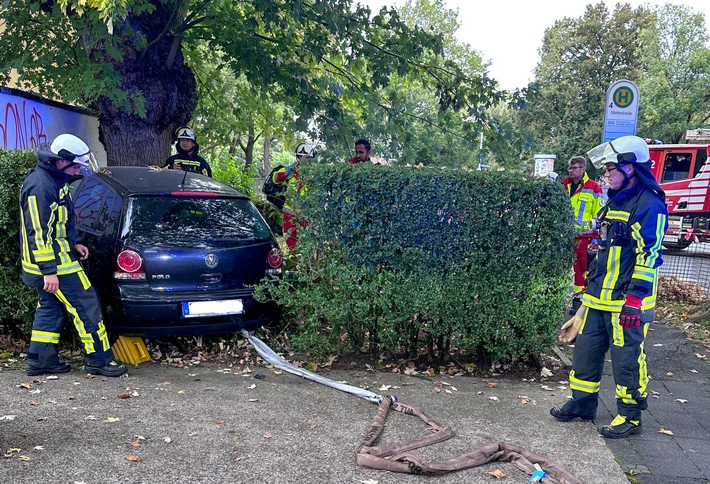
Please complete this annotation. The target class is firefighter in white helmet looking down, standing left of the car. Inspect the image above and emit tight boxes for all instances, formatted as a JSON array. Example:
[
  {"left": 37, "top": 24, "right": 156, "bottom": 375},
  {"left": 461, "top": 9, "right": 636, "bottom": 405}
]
[{"left": 20, "top": 134, "right": 127, "bottom": 376}]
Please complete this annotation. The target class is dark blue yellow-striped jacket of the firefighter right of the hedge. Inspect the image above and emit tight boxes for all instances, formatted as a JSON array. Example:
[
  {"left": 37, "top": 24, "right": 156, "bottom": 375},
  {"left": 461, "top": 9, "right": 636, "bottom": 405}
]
[{"left": 582, "top": 183, "right": 668, "bottom": 312}]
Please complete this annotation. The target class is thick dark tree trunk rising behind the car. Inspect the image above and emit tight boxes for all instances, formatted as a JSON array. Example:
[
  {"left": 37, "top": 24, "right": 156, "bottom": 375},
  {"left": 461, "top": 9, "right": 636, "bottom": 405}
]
[{"left": 92, "top": 0, "right": 199, "bottom": 166}]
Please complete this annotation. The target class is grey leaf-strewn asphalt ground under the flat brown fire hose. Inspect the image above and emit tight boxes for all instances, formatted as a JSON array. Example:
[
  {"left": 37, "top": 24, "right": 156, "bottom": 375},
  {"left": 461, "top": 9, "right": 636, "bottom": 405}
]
[{"left": 0, "top": 348, "right": 626, "bottom": 484}]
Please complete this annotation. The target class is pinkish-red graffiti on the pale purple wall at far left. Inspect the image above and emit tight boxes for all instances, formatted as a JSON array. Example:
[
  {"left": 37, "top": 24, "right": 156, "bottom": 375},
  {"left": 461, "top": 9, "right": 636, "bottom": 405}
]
[{"left": 0, "top": 99, "right": 47, "bottom": 150}]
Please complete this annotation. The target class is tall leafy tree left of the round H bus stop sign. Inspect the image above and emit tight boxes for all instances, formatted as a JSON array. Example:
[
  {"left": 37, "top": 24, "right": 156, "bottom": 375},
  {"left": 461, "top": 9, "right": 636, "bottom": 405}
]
[{"left": 520, "top": 2, "right": 653, "bottom": 173}]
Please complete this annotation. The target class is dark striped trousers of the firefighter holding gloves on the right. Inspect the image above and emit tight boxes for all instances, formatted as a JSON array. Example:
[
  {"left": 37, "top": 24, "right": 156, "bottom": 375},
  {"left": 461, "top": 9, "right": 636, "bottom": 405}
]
[{"left": 563, "top": 308, "right": 648, "bottom": 420}]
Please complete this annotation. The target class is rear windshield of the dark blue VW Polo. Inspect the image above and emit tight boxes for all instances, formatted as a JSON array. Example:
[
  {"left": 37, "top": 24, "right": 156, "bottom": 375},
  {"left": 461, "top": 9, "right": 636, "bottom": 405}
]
[{"left": 121, "top": 197, "right": 271, "bottom": 247}]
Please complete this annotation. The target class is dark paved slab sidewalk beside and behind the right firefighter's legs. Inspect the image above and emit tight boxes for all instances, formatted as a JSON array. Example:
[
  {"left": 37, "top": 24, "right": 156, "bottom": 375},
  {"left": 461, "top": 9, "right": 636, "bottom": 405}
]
[{"left": 595, "top": 323, "right": 710, "bottom": 484}]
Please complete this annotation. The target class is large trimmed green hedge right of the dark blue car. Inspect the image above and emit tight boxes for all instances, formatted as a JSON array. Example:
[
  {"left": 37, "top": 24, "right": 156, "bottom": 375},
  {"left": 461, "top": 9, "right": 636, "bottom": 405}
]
[{"left": 262, "top": 165, "right": 574, "bottom": 359}]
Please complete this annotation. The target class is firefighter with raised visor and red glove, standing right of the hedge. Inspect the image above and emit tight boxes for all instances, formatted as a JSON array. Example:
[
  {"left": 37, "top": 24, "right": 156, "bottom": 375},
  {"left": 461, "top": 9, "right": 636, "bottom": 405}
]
[{"left": 550, "top": 136, "right": 668, "bottom": 438}]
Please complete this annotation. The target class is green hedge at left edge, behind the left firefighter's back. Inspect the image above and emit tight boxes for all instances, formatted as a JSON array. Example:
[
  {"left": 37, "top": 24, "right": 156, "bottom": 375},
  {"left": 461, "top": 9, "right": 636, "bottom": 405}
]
[{"left": 0, "top": 150, "right": 37, "bottom": 334}]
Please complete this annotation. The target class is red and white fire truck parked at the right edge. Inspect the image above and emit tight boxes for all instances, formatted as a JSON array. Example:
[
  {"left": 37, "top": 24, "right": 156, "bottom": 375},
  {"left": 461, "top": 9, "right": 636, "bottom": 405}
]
[{"left": 648, "top": 144, "right": 710, "bottom": 249}]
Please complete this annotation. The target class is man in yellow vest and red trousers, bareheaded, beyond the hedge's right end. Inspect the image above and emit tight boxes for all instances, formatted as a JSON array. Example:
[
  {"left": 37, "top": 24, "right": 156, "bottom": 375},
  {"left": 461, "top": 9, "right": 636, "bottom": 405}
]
[{"left": 562, "top": 156, "right": 602, "bottom": 314}]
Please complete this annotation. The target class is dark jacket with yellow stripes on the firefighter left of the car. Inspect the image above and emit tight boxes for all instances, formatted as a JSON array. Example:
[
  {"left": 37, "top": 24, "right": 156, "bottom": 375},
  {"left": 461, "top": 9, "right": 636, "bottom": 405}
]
[{"left": 20, "top": 161, "right": 82, "bottom": 287}]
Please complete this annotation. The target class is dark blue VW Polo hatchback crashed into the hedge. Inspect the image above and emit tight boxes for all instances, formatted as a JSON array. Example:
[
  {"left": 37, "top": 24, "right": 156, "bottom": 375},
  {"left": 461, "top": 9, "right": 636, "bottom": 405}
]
[{"left": 73, "top": 167, "right": 283, "bottom": 336}]
